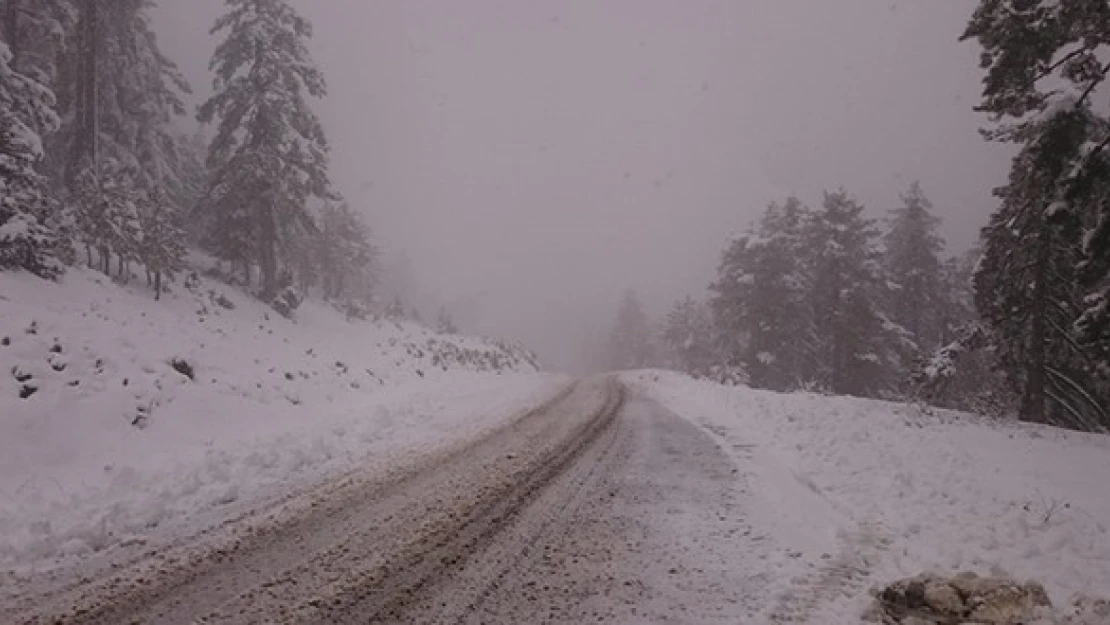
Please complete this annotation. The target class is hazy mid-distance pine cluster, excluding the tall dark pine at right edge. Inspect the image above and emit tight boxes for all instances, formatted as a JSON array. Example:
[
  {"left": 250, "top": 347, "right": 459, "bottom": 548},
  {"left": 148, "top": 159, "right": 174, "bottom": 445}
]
[{"left": 611, "top": 183, "right": 1007, "bottom": 410}]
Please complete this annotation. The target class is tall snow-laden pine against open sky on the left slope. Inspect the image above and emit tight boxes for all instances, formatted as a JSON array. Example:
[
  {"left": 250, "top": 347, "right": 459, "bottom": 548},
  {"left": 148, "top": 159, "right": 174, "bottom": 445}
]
[{"left": 198, "top": 0, "right": 332, "bottom": 299}]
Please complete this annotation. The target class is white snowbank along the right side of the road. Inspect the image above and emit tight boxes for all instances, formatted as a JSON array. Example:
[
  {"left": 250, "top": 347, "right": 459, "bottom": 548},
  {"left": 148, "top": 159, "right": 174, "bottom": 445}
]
[{"left": 626, "top": 372, "right": 1110, "bottom": 624}]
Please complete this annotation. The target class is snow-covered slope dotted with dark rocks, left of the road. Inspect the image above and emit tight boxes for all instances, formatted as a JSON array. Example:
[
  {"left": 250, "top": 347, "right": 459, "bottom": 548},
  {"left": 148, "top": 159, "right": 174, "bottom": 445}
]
[{"left": 0, "top": 270, "right": 563, "bottom": 569}]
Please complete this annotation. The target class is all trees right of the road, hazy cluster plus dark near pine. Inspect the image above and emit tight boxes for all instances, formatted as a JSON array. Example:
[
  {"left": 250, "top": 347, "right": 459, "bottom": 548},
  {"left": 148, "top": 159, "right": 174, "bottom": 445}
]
[{"left": 611, "top": 0, "right": 1110, "bottom": 432}]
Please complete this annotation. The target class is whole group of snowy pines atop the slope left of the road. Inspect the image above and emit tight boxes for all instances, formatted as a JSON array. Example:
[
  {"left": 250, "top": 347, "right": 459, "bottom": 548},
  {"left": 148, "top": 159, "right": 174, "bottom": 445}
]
[{"left": 0, "top": 0, "right": 376, "bottom": 310}]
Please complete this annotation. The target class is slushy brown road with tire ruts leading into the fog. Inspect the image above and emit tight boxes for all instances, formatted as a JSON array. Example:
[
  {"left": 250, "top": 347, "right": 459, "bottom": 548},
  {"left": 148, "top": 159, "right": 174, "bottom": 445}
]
[{"left": 0, "top": 379, "right": 767, "bottom": 625}]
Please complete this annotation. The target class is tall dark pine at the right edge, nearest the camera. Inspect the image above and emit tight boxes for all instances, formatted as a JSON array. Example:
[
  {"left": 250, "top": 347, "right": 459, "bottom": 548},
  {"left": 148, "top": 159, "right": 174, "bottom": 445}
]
[{"left": 963, "top": 0, "right": 1110, "bottom": 429}]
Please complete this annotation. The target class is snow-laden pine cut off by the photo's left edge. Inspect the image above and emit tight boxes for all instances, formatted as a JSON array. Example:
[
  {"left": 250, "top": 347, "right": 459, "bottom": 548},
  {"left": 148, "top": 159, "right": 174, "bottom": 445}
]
[{"left": 0, "top": 20, "right": 61, "bottom": 278}]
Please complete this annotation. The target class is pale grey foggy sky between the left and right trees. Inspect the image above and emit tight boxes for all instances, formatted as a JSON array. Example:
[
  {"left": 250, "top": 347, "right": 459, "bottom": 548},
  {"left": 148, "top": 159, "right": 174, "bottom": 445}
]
[{"left": 157, "top": 0, "right": 1009, "bottom": 367}]
